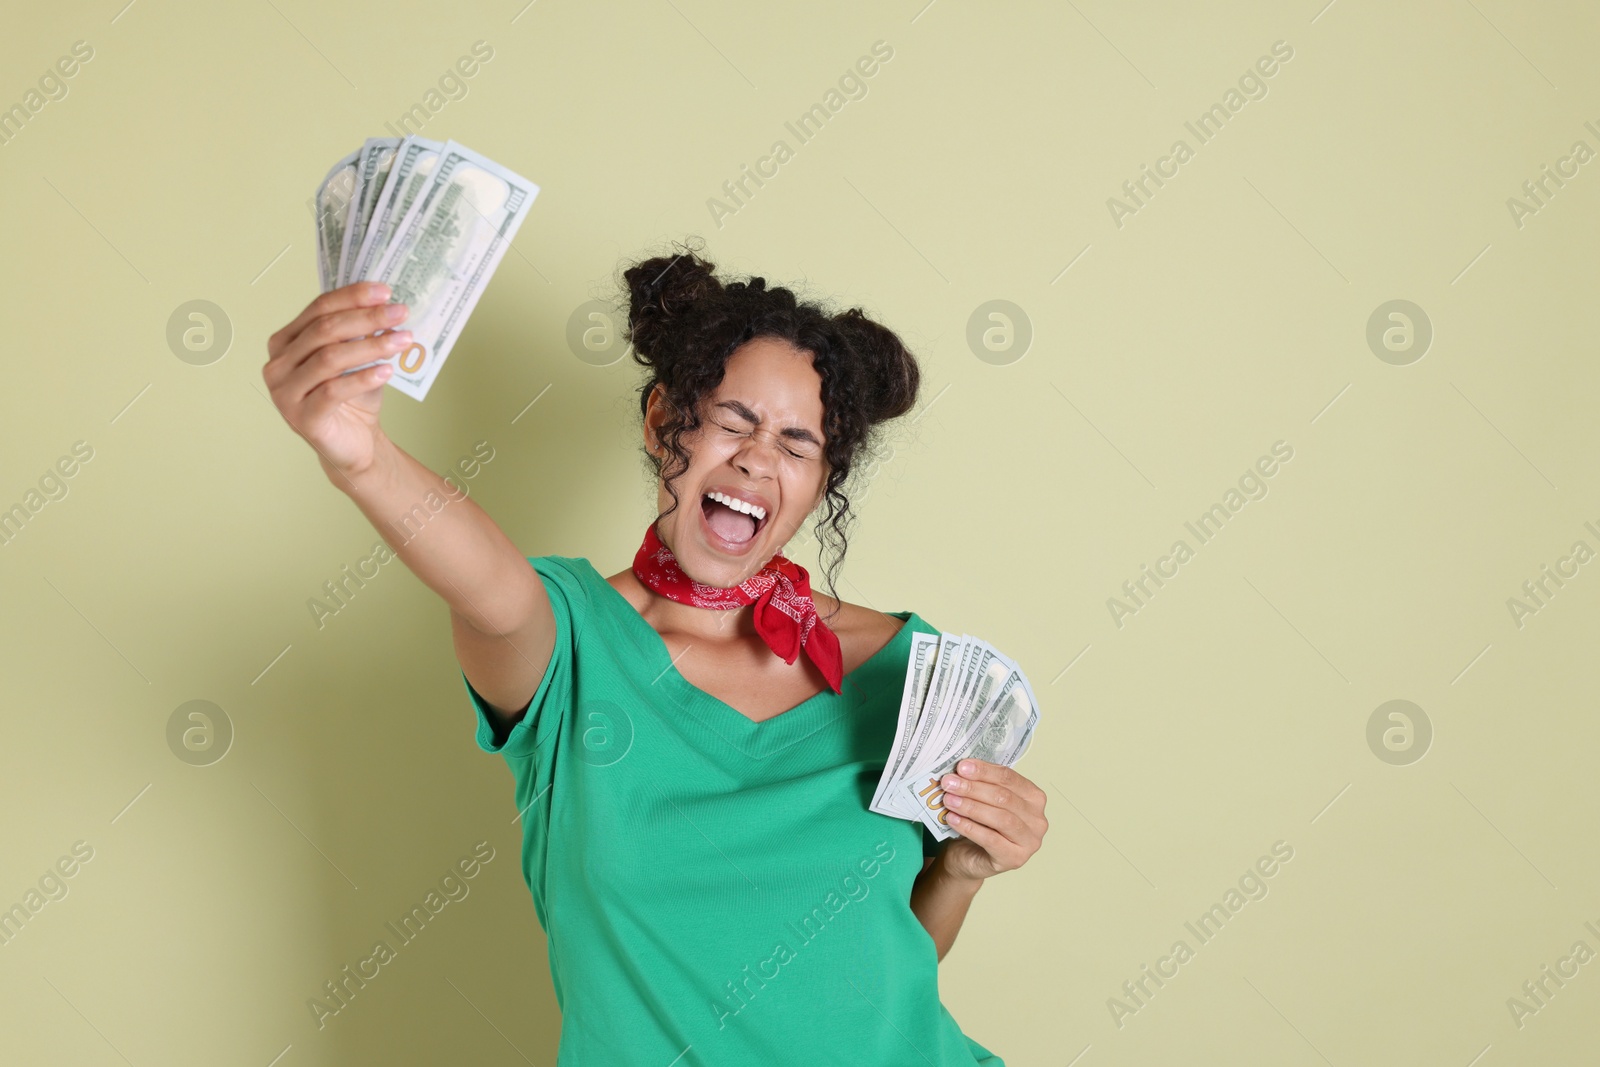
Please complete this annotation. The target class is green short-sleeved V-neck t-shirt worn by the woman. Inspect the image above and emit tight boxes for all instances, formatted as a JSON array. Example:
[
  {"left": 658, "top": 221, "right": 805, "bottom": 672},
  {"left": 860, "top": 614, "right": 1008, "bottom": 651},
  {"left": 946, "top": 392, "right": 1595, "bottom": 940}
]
[{"left": 462, "top": 555, "right": 1003, "bottom": 1067}]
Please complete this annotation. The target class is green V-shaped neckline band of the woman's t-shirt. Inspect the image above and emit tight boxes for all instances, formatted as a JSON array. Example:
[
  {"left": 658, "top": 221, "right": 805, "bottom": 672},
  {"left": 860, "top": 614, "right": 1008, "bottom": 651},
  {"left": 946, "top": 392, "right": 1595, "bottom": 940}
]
[{"left": 584, "top": 558, "right": 926, "bottom": 758}]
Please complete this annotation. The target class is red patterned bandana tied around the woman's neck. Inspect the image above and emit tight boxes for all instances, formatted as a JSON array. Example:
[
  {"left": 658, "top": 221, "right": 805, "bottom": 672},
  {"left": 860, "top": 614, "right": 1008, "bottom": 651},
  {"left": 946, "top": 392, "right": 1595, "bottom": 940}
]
[{"left": 634, "top": 523, "right": 845, "bottom": 693}]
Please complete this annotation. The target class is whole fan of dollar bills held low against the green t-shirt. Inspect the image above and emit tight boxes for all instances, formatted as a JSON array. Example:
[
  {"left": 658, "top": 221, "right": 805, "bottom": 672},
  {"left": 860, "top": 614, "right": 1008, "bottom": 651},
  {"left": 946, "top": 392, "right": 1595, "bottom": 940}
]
[{"left": 869, "top": 633, "right": 1038, "bottom": 841}]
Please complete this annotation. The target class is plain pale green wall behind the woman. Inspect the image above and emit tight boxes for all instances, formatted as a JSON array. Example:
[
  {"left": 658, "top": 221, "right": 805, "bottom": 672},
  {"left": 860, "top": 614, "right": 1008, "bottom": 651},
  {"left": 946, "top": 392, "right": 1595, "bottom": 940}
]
[{"left": 0, "top": 0, "right": 1600, "bottom": 1067}]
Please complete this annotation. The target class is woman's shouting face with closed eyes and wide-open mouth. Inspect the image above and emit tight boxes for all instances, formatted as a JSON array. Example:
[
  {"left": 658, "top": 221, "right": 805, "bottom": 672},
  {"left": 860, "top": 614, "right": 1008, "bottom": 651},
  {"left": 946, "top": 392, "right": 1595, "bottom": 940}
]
[{"left": 645, "top": 338, "right": 827, "bottom": 589}]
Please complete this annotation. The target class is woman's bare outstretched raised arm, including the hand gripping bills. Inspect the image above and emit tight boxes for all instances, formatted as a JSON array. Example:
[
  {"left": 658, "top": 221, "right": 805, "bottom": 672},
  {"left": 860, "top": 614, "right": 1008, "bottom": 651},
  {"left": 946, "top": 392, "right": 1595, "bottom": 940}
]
[{"left": 261, "top": 282, "right": 555, "bottom": 729}]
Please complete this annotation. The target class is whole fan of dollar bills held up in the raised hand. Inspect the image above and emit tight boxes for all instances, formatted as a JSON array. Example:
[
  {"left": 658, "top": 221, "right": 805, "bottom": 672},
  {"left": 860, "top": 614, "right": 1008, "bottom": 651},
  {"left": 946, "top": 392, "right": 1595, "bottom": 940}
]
[{"left": 314, "top": 138, "right": 539, "bottom": 400}]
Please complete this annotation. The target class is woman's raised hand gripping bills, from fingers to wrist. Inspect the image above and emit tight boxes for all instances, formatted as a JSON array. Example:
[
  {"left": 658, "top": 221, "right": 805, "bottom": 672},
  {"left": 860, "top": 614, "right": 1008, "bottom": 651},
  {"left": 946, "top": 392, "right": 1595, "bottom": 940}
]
[{"left": 261, "top": 282, "right": 411, "bottom": 477}]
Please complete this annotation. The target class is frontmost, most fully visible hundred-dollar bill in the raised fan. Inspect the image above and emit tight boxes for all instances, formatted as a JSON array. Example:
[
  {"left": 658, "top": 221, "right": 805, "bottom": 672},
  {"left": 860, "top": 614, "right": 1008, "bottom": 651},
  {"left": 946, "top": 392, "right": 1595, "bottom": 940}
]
[{"left": 352, "top": 141, "right": 539, "bottom": 400}]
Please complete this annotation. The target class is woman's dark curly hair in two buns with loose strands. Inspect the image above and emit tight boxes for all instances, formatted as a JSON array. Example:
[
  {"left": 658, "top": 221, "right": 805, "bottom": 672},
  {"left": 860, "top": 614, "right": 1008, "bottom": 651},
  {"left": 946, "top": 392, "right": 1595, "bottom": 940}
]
[{"left": 622, "top": 236, "right": 922, "bottom": 614}]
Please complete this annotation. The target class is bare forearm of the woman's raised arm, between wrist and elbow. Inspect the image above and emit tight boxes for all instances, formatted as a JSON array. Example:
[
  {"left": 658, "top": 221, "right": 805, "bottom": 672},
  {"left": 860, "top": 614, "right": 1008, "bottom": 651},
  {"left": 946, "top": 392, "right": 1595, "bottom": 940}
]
[{"left": 322, "top": 435, "right": 538, "bottom": 633}]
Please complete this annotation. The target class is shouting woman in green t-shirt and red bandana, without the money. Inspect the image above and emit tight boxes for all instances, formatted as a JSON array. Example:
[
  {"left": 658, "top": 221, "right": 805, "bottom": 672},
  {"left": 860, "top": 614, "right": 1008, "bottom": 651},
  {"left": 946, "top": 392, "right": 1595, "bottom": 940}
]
[{"left": 262, "top": 250, "right": 1046, "bottom": 1067}]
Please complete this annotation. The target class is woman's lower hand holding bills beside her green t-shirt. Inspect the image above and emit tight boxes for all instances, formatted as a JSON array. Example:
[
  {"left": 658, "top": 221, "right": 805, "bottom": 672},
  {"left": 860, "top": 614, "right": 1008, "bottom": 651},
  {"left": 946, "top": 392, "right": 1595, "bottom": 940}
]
[{"left": 939, "top": 760, "right": 1050, "bottom": 880}]
